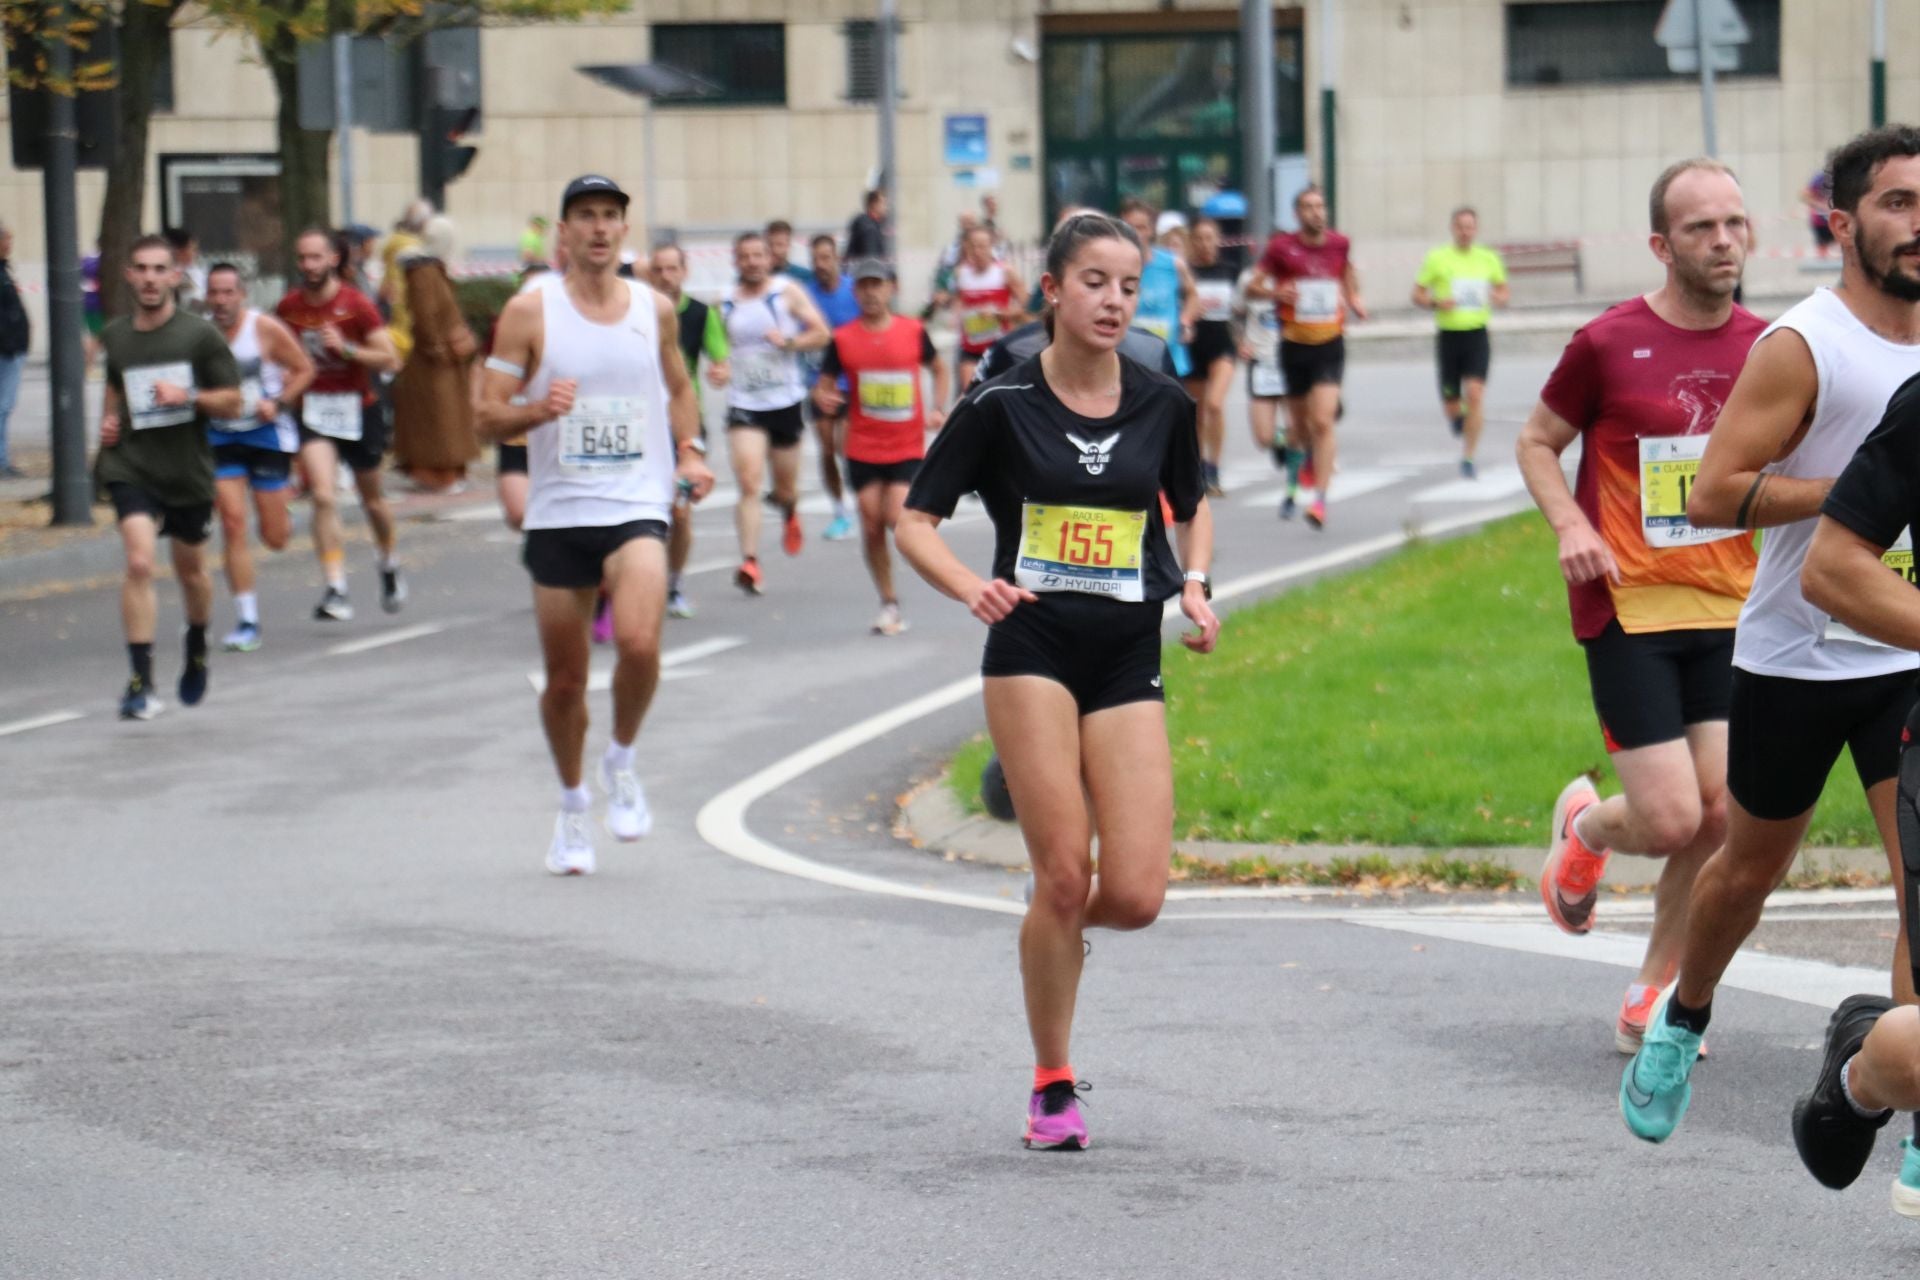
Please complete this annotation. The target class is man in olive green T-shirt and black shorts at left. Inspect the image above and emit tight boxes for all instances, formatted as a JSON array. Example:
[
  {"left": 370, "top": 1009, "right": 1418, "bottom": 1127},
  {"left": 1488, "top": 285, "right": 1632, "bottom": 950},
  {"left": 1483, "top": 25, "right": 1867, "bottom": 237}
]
[{"left": 94, "top": 236, "right": 248, "bottom": 720}]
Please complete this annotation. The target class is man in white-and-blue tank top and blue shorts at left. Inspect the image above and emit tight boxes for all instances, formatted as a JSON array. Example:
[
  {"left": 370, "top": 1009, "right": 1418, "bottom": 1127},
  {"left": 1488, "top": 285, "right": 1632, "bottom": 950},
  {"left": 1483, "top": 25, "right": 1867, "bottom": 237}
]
[{"left": 205, "top": 263, "right": 313, "bottom": 652}]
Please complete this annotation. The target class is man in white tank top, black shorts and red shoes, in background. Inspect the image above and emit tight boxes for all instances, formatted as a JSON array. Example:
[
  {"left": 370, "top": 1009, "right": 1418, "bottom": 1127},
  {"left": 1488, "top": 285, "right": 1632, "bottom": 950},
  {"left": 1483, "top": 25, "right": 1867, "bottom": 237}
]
[{"left": 720, "top": 232, "right": 831, "bottom": 595}]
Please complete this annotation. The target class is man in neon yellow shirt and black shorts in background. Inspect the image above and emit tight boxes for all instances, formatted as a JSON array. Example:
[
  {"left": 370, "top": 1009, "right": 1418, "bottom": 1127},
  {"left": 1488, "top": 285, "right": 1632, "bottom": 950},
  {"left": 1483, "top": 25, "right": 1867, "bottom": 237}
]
[{"left": 1413, "top": 207, "right": 1507, "bottom": 480}]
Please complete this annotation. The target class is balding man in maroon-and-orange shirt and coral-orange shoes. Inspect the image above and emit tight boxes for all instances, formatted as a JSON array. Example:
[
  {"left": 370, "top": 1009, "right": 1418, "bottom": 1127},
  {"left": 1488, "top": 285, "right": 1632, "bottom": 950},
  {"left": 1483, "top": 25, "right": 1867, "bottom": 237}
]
[{"left": 1519, "top": 159, "right": 1766, "bottom": 1054}]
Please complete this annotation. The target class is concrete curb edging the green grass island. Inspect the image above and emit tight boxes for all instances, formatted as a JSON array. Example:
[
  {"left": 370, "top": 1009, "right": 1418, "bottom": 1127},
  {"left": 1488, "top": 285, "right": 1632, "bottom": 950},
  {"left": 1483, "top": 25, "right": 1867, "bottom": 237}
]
[{"left": 899, "top": 773, "right": 1887, "bottom": 889}]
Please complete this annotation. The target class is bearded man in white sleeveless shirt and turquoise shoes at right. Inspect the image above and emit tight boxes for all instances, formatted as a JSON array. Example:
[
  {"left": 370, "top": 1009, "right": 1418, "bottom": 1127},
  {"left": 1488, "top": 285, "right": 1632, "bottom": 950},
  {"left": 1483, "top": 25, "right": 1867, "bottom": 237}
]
[{"left": 1620, "top": 129, "right": 1920, "bottom": 1142}]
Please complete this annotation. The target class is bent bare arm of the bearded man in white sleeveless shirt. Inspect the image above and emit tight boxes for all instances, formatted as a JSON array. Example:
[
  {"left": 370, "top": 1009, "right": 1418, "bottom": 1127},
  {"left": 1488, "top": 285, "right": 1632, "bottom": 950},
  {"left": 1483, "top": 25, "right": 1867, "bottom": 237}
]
[{"left": 1686, "top": 328, "right": 1834, "bottom": 530}]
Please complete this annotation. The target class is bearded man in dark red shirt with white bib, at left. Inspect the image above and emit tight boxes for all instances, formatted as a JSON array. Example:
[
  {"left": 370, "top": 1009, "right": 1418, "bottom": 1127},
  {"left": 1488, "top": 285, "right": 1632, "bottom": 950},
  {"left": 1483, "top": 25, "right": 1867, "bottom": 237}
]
[{"left": 275, "top": 226, "right": 407, "bottom": 622}]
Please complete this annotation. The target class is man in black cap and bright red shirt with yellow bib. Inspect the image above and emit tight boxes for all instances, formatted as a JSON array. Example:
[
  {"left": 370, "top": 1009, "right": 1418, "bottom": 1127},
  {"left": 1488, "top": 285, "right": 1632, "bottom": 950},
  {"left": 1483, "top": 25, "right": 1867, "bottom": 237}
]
[{"left": 814, "top": 257, "right": 948, "bottom": 635}]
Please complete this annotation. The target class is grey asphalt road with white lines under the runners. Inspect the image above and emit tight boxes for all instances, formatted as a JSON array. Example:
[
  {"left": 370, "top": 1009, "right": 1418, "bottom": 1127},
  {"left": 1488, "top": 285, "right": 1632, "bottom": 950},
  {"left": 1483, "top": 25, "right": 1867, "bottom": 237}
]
[{"left": 0, "top": 357, "right": 1920, "bottom": 1280}]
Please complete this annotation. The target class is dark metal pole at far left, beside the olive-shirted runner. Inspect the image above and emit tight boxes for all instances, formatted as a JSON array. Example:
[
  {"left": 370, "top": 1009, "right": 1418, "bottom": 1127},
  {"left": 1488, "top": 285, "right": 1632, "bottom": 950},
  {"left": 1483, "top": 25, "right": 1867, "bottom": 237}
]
[{"left": 42, "top": 2, "right": 90, "bottom": 524}]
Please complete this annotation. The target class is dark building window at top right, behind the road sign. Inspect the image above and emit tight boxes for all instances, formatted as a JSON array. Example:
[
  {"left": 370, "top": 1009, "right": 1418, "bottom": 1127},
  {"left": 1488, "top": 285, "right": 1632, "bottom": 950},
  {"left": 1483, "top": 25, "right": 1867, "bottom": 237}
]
[{"left": 1507, "top": 0, "right": 1780, "bottom": 88}]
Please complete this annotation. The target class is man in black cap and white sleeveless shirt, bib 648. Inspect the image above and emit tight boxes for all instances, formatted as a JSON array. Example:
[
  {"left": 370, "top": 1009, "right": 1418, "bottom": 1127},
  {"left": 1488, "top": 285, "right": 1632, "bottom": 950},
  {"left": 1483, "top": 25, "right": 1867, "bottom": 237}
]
[{"left": 476, "top": 175, "right": 712, "bottom": 875}]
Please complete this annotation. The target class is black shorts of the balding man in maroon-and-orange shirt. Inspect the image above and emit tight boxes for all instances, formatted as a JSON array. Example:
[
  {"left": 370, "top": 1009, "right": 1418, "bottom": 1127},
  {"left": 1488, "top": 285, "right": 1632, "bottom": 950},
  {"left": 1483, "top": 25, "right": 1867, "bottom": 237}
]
[{"left": 1580, "top": 620, "right": 1734, "bottom": 752}]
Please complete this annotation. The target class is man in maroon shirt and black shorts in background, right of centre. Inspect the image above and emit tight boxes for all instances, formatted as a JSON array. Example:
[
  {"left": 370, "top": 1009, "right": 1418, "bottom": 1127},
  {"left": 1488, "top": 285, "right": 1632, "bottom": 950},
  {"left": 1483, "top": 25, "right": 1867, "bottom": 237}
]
[{"left": 1248, "top": 186, "right": 1367, "bottom": 530}]
